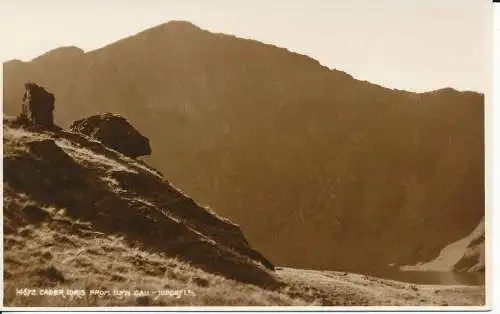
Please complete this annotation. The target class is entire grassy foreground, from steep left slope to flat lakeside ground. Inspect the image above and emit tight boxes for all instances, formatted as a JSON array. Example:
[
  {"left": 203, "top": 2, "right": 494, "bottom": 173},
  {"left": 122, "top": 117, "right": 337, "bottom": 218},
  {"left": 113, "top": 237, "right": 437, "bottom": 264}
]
[{"left": 3, "top": 119, "right": 484, "bottom": 306}]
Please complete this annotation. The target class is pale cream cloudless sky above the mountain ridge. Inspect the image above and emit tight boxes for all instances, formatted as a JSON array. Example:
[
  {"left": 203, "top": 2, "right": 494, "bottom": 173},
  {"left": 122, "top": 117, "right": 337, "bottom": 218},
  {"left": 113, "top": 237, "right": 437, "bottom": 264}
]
[{"left": 0, "top": 0, "right": 492, "bottom": 92}]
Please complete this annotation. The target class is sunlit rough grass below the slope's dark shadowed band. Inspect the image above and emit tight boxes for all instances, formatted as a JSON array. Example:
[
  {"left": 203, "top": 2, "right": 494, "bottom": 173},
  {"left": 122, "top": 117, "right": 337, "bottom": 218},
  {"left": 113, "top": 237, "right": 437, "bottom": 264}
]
[{"left": 4, "top": 204, "right": 306, "bottom": 306}]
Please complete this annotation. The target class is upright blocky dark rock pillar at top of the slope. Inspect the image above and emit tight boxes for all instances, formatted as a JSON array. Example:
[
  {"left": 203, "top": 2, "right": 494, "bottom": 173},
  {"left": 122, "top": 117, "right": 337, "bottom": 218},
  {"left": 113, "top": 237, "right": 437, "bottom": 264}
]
[{"left": 19, "top": 83, "right": 55, "bottom": 127}]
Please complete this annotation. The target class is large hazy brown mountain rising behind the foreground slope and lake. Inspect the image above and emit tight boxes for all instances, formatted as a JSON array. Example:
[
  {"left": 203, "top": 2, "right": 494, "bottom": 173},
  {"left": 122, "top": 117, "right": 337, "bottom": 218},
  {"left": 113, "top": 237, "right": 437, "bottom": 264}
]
[{"left": 0, "top": 22, "right": 484, "bottom": 270}]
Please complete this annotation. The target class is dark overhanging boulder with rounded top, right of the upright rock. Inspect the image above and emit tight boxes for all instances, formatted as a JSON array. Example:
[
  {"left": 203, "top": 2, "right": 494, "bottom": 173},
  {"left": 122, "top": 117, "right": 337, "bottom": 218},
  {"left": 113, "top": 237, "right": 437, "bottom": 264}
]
[{"left": 70, "top": 113, "right": 151, "bottom": 158}]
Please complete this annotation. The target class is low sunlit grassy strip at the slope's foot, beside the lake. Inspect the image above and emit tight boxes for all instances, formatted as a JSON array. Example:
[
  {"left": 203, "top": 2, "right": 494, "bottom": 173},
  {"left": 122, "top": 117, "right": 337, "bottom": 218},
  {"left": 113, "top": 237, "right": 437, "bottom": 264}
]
[{"left": 276, "top": 267, "right": 486, "bottom": 307}]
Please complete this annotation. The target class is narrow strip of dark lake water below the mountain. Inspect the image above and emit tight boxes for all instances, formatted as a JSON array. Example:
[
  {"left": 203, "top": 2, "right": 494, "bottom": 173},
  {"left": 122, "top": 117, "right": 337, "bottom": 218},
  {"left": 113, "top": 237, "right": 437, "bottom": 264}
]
[{"left": 365, "top": 268, "right": 485, "bottom": 286}]
